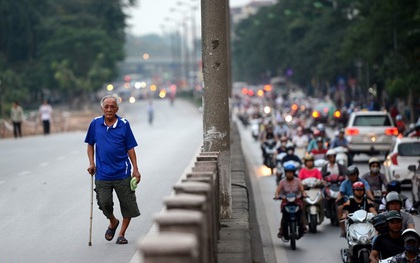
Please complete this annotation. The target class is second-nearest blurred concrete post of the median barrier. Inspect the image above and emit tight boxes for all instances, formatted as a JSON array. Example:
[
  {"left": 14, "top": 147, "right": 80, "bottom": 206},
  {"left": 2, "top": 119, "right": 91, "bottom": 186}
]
[{"left": 155, "top": 209, "right": 207, "bottom": 263}]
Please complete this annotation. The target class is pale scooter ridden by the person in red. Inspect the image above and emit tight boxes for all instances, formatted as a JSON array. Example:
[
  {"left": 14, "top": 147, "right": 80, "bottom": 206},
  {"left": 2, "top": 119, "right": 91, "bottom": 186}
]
[{"left": 302, "top": 178, "right": 324, "bottom": 233}]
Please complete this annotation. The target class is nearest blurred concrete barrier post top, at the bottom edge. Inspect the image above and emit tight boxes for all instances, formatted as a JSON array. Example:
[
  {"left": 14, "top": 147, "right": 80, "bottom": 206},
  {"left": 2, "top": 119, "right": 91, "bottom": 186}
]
[{"left": 139, "top": 233, "right": 201, "bottom": 263}]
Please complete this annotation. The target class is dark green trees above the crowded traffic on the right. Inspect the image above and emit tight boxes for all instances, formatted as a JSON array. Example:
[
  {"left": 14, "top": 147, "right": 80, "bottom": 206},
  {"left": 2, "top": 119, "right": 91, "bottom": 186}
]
[{"left": 232, "top": 0, "right": 420, "bottom": 102}]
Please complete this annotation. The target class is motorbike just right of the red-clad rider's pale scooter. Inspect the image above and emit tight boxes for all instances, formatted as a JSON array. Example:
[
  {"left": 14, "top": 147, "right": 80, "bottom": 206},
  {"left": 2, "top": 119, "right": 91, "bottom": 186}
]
[{"left": 324, "top": 174, "right": 345, "bottom": 226}]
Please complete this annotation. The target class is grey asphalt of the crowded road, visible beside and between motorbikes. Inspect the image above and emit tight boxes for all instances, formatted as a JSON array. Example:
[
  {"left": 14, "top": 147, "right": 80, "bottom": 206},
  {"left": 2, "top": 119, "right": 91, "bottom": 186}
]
[{"left": 238, "top": 119, "right": 420, "bottom": 263}]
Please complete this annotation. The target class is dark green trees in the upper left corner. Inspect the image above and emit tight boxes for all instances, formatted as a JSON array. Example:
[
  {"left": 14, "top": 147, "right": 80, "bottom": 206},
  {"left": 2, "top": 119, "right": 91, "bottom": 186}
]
[{"left": 0, "top": 0, "right": 135, "bottom": 115}]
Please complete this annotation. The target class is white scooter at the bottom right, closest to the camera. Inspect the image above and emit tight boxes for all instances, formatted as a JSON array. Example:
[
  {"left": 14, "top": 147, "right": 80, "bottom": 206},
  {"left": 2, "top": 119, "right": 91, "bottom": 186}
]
[{"left": 341, "top": 210, "right": 376, "bottom": 263}]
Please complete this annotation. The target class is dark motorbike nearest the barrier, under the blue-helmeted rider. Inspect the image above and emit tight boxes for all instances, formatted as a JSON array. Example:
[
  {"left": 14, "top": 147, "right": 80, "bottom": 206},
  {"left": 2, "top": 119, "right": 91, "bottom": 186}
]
[{"left": 279, "top": 193, "right": 303, "bottom": 250}]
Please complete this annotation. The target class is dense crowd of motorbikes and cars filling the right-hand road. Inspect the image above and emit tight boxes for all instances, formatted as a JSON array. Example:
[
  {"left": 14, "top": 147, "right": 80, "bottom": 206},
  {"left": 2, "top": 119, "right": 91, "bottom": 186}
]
[{"left": 234, "top": 83, "right": 420, "bottom": 263}]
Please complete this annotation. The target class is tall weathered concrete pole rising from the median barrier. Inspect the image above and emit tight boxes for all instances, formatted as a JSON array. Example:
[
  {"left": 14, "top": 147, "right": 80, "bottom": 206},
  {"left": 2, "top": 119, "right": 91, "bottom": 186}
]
[{"left": 201, "top": 0, "right": 232, "bottom": 218}]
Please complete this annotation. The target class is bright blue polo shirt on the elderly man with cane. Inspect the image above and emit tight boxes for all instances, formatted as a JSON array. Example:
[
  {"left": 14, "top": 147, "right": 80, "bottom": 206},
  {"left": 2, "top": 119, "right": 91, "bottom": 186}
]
[{"left": 85, "top": 116, "right": 137, "bottom": 181}]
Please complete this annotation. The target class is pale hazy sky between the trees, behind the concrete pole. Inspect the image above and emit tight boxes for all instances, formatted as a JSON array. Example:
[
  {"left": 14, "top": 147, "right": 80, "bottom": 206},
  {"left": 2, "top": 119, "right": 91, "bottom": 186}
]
[{"left": 127, "top": 0, "right": 252, "bottom": 35}]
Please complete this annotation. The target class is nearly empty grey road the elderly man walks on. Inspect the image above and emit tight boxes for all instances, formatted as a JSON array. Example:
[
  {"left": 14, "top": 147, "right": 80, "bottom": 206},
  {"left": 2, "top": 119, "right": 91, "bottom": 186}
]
[{"left": 0, "top": 100, "right": 203, "bottom": 263}]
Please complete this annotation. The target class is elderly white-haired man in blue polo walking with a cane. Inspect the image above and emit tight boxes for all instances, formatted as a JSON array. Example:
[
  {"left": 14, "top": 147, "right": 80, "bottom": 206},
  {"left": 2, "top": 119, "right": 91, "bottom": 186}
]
[{"left": 85, "top": 95, "right": 141, "bottom": 244}]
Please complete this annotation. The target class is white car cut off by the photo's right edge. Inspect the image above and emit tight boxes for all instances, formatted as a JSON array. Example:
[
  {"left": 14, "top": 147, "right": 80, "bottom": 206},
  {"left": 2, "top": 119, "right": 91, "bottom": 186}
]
[{"left": 384, "top": 137, "right": 420, "bottom": 183}]
